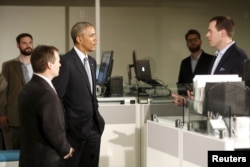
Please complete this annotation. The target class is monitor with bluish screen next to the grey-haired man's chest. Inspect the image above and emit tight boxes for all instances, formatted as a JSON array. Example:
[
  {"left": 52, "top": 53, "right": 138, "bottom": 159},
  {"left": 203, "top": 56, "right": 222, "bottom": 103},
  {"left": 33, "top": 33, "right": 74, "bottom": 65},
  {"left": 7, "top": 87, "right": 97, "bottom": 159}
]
[{"left": 96, "top": 51, "right": 114, "bottom": 85}]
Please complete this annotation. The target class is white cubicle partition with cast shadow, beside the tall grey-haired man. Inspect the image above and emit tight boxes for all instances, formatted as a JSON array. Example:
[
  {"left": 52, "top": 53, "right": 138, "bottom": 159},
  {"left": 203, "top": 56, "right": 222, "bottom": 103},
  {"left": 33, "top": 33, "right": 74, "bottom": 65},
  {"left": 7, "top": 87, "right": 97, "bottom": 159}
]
[{"left": 98, "top": 97, "right": 140, "bottom": 167}]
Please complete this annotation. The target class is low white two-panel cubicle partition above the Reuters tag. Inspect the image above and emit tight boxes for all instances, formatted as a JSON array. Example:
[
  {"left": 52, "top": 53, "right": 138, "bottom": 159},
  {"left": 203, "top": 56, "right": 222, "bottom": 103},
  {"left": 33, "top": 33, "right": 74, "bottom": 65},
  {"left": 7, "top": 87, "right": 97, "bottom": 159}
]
[{"left": 147, "top": 117, "right": 250, "bottom": 167}]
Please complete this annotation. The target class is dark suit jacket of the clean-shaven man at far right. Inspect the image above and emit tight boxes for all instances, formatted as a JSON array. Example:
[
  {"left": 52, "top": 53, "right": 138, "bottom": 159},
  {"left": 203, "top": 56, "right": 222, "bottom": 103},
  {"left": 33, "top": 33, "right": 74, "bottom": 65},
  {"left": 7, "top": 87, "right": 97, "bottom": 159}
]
[{"left": 209, "top": 44, "right": 248, "bottom": 77}]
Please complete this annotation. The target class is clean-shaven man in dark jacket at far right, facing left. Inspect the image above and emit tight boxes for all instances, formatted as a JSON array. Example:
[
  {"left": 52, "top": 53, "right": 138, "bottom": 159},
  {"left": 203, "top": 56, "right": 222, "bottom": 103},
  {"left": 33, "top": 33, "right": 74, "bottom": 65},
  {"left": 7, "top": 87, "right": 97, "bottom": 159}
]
[{"left": 206, "top": 16, "right": 248, "bottom": 77}]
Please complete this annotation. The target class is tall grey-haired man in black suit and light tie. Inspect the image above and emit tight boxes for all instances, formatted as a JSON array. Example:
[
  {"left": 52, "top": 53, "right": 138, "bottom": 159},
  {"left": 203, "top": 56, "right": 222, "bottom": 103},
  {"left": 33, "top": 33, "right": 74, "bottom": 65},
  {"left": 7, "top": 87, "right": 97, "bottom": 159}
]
[{"left": 53, "top": 22, "right": 105, "bottom": 167}]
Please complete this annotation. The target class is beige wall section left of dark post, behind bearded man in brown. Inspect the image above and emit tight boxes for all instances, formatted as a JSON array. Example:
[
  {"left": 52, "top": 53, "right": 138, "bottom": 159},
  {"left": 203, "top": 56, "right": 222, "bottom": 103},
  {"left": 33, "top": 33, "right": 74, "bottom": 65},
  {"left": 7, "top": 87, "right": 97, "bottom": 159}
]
[{"left": 0, "top": 6, "right": 65, "bottom": 64}]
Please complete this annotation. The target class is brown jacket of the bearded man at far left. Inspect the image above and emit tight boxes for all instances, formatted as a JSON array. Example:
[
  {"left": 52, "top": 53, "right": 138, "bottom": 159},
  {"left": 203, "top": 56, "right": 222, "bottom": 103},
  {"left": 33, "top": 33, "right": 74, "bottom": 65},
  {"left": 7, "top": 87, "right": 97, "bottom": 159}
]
[{"left": 0, "top": 57, "right": 25, "bottom": 127}]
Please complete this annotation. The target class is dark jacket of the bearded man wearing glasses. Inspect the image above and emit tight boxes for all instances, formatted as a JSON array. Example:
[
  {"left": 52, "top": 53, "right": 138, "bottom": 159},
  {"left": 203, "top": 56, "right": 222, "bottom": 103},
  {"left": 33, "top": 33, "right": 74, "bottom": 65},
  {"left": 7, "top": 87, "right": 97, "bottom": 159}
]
[{"left": 178, "top": 51, "right": 214, "bottom": 84}]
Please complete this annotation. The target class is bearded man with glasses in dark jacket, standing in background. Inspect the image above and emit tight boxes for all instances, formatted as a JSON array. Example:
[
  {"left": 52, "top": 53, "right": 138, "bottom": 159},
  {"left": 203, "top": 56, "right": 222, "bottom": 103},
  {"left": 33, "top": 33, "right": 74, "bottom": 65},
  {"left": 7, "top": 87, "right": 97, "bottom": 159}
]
[{"left": 177, "top": 29, "right": 214, "bottom": 95}]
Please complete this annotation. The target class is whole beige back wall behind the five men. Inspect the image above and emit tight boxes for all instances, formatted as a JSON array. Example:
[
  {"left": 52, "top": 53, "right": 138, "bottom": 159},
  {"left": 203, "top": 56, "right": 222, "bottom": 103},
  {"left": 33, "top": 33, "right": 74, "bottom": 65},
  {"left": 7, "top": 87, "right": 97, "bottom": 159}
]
[{"left": 0, "top": 4, "right": 250, "bottom": 84}]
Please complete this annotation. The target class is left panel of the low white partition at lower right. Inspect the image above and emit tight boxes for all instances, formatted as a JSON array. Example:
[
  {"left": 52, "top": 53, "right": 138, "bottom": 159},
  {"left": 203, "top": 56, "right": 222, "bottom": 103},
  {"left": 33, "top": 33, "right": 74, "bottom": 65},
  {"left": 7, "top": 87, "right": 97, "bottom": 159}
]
[{"left": 146, "top": 121, "right": 182, "bottom": 167}]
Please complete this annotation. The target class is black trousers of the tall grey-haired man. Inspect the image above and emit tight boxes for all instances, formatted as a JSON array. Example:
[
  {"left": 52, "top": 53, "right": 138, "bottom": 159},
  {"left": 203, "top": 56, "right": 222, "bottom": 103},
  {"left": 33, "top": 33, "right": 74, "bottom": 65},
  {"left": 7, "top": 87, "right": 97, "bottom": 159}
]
[{"left": 66, "top": 124, "right": 101, "bottom": 167}]
